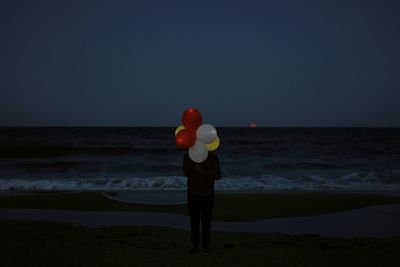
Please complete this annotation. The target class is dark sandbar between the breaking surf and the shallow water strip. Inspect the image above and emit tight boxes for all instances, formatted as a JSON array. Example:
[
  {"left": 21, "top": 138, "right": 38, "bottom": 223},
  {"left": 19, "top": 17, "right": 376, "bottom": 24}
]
[{"left": 0, "top": 191, "right": 400, "bottom": 221}]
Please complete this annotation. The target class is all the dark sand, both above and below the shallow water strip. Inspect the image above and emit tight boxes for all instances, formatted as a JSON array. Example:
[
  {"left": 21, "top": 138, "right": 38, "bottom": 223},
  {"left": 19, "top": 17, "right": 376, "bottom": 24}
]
[{"left": 0, "top": 192, "right": 400, "bottom": 266}]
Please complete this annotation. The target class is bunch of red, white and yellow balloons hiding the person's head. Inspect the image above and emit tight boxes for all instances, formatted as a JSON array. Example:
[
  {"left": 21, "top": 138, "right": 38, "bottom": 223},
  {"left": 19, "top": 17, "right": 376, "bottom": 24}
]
[{"left": 175, "top": 108, "right": 220, "bottom": 163}]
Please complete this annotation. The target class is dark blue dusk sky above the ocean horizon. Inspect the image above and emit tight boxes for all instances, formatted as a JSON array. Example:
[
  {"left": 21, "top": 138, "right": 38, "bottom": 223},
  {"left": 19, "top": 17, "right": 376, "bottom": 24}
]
[{"left": 0, "top": 0, "right": 400, "bottom": 127}]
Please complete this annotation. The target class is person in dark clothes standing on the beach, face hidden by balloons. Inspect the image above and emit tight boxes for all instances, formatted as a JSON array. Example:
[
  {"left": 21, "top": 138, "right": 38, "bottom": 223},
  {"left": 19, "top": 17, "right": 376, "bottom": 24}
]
[{"left": 183, "top": 151, "right": 221, "bottom": 255}]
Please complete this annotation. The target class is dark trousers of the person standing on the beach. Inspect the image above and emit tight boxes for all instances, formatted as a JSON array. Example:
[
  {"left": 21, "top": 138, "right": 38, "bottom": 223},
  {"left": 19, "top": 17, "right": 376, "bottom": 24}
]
[{"left": 187, "top": 193, "right": 214, "bottom": 246}]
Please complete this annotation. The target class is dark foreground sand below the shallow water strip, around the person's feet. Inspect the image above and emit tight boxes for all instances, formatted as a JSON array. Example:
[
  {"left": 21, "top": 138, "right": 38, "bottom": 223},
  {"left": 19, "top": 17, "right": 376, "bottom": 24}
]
[{"left": 0, "top": 222, "right": 400, "bottom": 266}]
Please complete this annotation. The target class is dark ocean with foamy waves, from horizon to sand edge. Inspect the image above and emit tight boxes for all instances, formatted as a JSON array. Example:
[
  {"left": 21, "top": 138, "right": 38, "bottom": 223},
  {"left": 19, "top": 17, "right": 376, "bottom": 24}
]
[{"left": 0, "top": 126, "right": 400, "bottom": 192}]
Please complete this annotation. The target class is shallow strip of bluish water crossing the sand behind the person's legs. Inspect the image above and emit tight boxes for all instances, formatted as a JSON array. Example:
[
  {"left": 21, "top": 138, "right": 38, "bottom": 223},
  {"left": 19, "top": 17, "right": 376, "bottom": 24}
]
[{"left": 0, "top": 203, "right": 400, "bottom": 238}]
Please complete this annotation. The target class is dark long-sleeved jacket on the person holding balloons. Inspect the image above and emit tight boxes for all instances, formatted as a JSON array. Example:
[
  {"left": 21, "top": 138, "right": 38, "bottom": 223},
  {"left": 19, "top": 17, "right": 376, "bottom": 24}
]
[{"left": 183, "top": 151, "right": 221, "bottom": 195}]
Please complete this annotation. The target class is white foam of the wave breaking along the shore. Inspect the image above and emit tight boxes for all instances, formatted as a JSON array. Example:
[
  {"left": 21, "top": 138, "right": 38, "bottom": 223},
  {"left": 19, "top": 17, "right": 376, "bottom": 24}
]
[{"left": 0, "top": 173, "right": 400, "bottom": 191}]
